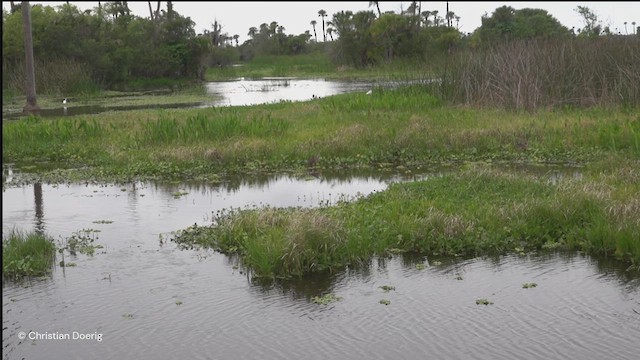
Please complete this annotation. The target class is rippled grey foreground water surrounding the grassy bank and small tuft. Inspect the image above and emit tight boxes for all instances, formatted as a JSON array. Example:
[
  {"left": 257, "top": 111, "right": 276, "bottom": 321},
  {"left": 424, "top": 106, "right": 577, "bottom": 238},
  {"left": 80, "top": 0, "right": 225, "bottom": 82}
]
[{"left": 2, "top": 170, "right": 640, "bottom": 360}]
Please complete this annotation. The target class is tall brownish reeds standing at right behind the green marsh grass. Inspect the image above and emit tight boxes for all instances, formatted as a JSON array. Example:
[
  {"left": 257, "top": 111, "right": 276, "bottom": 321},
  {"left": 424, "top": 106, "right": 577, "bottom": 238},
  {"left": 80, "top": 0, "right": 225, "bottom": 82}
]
[{"left": 441, "top": 36, "right": 640, "bottom": 110}]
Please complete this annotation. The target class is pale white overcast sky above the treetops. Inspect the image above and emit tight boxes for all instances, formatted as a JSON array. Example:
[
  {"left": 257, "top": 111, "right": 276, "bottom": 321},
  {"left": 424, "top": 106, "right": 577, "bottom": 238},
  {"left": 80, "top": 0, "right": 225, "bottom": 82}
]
[{"left": 2, "top": 1, "right": 640, "bottom": 43}]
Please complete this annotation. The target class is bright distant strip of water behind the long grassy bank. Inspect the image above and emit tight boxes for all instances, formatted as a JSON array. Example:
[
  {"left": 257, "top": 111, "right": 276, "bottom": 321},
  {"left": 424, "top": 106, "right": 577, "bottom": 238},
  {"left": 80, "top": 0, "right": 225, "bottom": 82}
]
[{"left": 2, "top": 77, "right": 382, "bottom": 120}]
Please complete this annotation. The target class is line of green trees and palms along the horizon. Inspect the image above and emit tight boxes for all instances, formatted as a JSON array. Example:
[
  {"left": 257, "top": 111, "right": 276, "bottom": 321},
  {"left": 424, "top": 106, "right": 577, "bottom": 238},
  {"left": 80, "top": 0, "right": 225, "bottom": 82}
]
[{"left": 2, "top": 1, "right": 637, "bottom": 95}]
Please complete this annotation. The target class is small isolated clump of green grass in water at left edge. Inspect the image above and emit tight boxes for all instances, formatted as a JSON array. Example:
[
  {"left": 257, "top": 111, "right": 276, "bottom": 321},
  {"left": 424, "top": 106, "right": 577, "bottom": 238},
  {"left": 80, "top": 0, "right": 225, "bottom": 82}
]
[{"left": 2, "top": 230, "right": 55, "bottom": 279}]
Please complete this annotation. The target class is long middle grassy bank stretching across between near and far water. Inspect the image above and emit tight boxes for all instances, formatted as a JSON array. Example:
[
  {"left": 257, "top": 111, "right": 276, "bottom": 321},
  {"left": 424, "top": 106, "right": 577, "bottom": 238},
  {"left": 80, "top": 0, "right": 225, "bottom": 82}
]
[{"left": 2, "top": 86, "right": 640, "bottom": 181}]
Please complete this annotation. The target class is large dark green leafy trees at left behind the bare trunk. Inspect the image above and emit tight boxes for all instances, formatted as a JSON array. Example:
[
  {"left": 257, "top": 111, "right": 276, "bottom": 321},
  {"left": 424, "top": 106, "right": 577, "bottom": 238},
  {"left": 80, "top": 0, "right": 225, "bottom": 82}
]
[{"left": 2, "top": 2, "right": 209, "bottom": 94}]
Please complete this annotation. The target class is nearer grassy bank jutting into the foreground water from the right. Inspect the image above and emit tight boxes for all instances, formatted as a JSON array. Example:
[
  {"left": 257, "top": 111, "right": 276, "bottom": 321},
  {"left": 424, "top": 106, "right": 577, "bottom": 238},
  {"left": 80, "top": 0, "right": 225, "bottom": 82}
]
[{"left": 174, "top": 162, "right": 640, "bottom": 278}]
